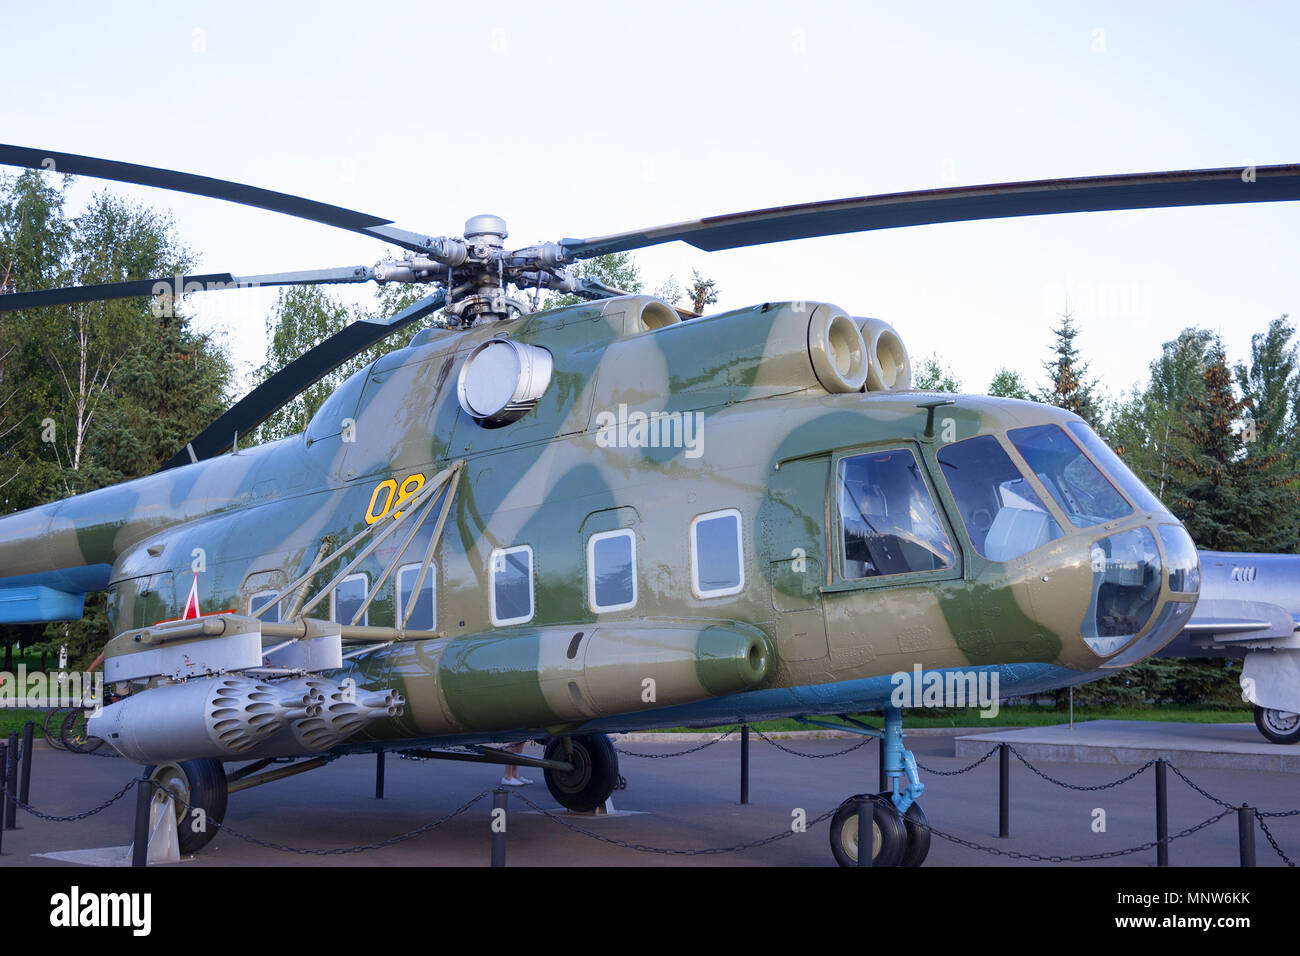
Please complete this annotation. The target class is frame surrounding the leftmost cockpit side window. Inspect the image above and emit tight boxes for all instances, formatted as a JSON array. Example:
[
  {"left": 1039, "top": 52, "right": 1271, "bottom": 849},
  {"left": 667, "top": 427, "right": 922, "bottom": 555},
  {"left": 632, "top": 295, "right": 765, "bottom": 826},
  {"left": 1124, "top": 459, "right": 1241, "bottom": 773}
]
[{"left": 820, "top": 440, "right": 970, "bottom": 593}]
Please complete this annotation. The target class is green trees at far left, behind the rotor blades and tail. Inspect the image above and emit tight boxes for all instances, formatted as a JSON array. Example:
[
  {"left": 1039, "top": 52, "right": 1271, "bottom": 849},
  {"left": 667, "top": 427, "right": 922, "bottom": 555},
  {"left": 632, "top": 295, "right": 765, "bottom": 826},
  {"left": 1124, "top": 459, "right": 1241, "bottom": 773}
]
[{"left": 0, "top": 170, "right": 230, "bottom": 666}]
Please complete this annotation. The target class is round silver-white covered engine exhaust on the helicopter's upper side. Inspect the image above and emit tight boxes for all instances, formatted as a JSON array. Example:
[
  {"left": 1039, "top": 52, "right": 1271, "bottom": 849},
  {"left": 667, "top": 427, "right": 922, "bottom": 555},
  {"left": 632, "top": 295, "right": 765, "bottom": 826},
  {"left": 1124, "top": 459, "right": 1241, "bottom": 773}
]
[{"left": 458, "top": 338, "right": 554, "bottom": 428}]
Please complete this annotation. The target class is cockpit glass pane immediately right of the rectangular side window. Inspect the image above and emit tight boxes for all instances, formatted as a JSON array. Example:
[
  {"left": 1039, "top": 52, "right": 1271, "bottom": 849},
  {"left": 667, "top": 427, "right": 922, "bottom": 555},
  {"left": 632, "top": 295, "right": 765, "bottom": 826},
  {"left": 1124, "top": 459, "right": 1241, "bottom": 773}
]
[{"left": 939, "top": 434, "right": 1062, "bottom": 561}]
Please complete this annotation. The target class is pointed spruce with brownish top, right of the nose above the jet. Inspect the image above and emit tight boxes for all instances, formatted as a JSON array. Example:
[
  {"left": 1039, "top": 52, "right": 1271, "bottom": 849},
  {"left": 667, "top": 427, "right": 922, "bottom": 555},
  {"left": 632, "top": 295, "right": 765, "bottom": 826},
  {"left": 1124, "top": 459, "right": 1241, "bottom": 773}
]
[{"left": 1166, "top": 338, "right": 1300, "bottom": 551}]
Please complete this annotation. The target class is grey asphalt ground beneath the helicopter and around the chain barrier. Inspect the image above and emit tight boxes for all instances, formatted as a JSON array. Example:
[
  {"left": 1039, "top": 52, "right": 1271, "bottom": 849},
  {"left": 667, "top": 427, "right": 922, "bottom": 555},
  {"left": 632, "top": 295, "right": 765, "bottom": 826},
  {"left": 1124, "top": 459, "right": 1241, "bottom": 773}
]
[{"left": 0, "top": 734, "right": 1300, "bottom": 868}]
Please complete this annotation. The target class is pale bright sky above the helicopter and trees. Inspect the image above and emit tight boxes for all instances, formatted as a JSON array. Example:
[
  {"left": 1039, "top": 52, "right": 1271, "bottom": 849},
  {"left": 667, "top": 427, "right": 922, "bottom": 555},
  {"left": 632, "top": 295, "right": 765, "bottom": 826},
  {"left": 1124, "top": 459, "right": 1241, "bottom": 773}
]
[{"left": 0, "top": 0, "right": 1300, "bottom": 397}]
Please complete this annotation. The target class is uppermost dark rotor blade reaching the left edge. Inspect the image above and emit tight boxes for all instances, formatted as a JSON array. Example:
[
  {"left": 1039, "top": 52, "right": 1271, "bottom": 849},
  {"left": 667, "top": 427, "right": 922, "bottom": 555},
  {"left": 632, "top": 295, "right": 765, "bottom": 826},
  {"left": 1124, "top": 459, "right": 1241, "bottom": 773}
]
[{"left": 0, "top": 144, "right": 437, "bottom": 252}]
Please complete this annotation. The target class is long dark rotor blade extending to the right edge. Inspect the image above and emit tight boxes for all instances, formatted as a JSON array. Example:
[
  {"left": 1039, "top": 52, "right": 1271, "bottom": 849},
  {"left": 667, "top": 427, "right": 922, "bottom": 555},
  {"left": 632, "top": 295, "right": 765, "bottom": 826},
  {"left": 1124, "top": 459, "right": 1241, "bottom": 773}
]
[{"left": 560, "top": 164, "right": 1300, "bottom": 259}]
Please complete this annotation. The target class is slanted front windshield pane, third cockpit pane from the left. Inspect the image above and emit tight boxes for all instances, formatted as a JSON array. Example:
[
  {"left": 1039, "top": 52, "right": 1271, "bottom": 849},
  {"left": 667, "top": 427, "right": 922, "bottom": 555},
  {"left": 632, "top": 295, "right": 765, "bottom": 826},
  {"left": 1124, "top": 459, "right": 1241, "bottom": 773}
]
[{"left": 1006, "top": 425, "right": 1132, "bottom": 528}]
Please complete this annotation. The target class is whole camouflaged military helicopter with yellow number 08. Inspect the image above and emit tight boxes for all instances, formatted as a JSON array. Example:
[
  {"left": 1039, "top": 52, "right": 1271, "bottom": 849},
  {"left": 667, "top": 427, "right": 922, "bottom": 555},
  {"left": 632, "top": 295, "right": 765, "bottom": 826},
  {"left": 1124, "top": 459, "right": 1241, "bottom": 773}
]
[{"left": 0, "top": 146, "right": 1300, "bottom": 865}]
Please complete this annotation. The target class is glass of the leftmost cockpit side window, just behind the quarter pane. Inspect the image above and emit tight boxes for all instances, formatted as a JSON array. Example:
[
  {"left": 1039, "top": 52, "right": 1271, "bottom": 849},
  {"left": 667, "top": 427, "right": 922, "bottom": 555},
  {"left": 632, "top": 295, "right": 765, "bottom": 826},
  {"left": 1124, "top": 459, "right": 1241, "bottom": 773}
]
[{"left": 837, "top": 449, "right": 954, "bottom": 579}]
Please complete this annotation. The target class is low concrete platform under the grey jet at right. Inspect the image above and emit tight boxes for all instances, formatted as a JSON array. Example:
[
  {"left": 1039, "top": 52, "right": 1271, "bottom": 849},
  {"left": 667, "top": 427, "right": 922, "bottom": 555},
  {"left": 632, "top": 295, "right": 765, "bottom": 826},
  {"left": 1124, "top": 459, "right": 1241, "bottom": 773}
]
[{"left": 954, "top": 721, "right": 1300, "bottom": 774}]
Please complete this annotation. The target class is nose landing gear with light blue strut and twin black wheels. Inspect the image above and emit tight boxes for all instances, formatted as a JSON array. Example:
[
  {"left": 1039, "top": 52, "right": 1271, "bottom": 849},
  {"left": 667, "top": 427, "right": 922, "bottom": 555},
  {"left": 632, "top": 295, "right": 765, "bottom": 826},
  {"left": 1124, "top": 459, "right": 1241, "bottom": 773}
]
[{"left": 809, "top": 708, "right": 930, "bottom": 866}]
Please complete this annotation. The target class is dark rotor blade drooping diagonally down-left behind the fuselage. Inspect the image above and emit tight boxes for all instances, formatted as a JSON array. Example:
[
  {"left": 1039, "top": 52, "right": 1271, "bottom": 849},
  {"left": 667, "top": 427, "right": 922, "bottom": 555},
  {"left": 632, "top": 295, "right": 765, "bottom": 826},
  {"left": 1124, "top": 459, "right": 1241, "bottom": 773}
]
[{"left": 160, "top": 289, "right": 447, "bottom": 471}]
